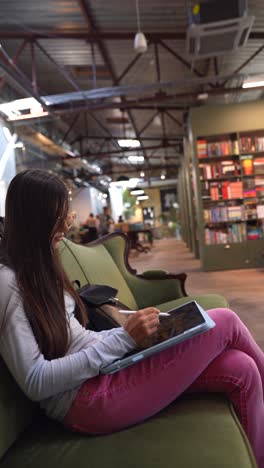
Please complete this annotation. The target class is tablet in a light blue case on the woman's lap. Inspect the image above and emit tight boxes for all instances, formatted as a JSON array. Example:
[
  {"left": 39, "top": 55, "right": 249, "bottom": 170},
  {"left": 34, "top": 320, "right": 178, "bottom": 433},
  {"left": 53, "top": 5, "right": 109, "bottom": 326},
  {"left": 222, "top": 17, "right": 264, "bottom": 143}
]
[{"left": 101, "top": 301, "right": 215, "bottom": 374}]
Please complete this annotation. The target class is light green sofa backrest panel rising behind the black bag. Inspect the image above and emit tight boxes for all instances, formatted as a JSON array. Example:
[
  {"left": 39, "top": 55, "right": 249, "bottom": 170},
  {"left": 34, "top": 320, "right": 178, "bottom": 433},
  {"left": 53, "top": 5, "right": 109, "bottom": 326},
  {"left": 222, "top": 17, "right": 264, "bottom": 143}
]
[{"left": 61, "top": 240, "right": 137, "bottom": 310}]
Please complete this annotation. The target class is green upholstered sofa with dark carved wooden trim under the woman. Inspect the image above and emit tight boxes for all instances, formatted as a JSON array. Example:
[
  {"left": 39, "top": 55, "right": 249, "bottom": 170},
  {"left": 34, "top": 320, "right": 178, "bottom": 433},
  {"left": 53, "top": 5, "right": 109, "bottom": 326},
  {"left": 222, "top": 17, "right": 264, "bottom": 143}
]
[{"left": 0, "top": 233, "right": 257, "bottom": 468}]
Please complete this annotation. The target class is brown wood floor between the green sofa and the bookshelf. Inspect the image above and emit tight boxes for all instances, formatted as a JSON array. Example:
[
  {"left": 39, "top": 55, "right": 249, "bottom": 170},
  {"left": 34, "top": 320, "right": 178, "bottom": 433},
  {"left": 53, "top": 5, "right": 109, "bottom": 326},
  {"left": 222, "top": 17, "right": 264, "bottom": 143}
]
[{"left": 129, "top": 238, "right": 264, "bottom": 351}]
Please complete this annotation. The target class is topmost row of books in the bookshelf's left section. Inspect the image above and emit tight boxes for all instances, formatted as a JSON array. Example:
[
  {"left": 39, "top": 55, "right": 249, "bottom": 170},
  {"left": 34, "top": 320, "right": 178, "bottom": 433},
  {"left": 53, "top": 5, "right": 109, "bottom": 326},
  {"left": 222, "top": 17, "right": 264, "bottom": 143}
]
[{"left": 197, "top": 139, "right": 239, "bottom": 158}]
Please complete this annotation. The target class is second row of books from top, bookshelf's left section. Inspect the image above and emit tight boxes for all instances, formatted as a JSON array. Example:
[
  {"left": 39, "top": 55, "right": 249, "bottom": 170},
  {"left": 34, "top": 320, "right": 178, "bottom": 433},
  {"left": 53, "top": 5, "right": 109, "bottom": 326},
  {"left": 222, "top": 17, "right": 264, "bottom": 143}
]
[{"left": 199, "top": 161, "right": 241, "bottom": 179}]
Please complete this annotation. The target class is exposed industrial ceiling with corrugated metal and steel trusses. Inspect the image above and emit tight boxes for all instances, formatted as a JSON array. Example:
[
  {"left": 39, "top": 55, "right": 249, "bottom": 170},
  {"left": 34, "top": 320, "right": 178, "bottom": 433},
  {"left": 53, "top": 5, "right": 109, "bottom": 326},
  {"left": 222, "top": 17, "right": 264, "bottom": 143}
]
[{"left": 0, "top": 0, "right": 264, "bottom": 188}]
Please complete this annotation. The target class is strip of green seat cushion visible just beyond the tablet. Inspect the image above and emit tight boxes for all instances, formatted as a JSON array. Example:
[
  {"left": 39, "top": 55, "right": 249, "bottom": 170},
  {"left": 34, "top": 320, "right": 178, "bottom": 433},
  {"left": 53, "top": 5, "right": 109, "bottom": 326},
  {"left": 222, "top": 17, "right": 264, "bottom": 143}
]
[{"left": 156, "top": 294, "right": 228, "bottom": 312}]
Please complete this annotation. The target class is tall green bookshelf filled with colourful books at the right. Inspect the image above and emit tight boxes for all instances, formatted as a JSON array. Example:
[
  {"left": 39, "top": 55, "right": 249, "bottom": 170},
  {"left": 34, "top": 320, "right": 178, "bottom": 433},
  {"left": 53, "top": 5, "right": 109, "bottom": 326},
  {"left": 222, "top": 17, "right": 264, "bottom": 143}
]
[{"left": 190, "top": 103, "right": 264, "bottom": 271}]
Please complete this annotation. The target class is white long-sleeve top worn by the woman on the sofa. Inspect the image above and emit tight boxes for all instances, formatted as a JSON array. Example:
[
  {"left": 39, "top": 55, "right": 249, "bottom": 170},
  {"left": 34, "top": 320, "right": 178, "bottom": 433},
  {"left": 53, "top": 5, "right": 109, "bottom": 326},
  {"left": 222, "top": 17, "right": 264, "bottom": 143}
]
[{"left": 0, "top": 265, "right": 136, "bottom": 420}]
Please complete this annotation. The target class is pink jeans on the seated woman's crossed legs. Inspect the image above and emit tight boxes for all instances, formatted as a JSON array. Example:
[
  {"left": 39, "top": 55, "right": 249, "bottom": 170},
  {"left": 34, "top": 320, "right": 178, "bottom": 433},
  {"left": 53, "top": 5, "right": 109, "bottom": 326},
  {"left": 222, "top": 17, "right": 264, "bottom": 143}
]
[{"left": 64, "top": 309, "right": 264, "bottom": 468}]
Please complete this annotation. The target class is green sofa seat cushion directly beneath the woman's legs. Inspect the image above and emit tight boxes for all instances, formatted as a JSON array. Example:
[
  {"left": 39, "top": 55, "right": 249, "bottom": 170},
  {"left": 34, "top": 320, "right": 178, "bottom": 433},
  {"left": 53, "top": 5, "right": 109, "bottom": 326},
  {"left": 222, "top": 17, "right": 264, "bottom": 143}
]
[{"left": 0, "top": 395, "right": 256, "bottom": 468}]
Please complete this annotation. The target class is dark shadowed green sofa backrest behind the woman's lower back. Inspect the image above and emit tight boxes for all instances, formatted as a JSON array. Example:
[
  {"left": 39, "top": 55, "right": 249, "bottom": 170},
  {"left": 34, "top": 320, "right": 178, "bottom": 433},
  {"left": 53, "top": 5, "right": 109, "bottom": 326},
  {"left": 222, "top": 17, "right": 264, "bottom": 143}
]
[{"left": 0, "top": 359, "right": 38, "bottom": 457}]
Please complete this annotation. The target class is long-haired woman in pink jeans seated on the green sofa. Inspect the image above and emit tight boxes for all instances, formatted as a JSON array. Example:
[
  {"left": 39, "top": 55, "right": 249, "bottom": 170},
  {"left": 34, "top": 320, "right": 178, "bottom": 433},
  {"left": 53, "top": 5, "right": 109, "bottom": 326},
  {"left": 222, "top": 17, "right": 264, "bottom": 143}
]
[{"left": 0, "top": 170, "right": 264, "bottom": 468}]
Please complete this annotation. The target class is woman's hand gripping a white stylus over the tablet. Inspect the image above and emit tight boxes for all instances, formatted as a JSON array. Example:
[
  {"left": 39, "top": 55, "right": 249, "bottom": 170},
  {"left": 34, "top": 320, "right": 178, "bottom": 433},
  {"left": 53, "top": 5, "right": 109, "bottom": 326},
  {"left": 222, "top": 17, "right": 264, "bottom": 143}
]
[{"left": 124, "top": 307, "right": 160, "bottom": 345}]
